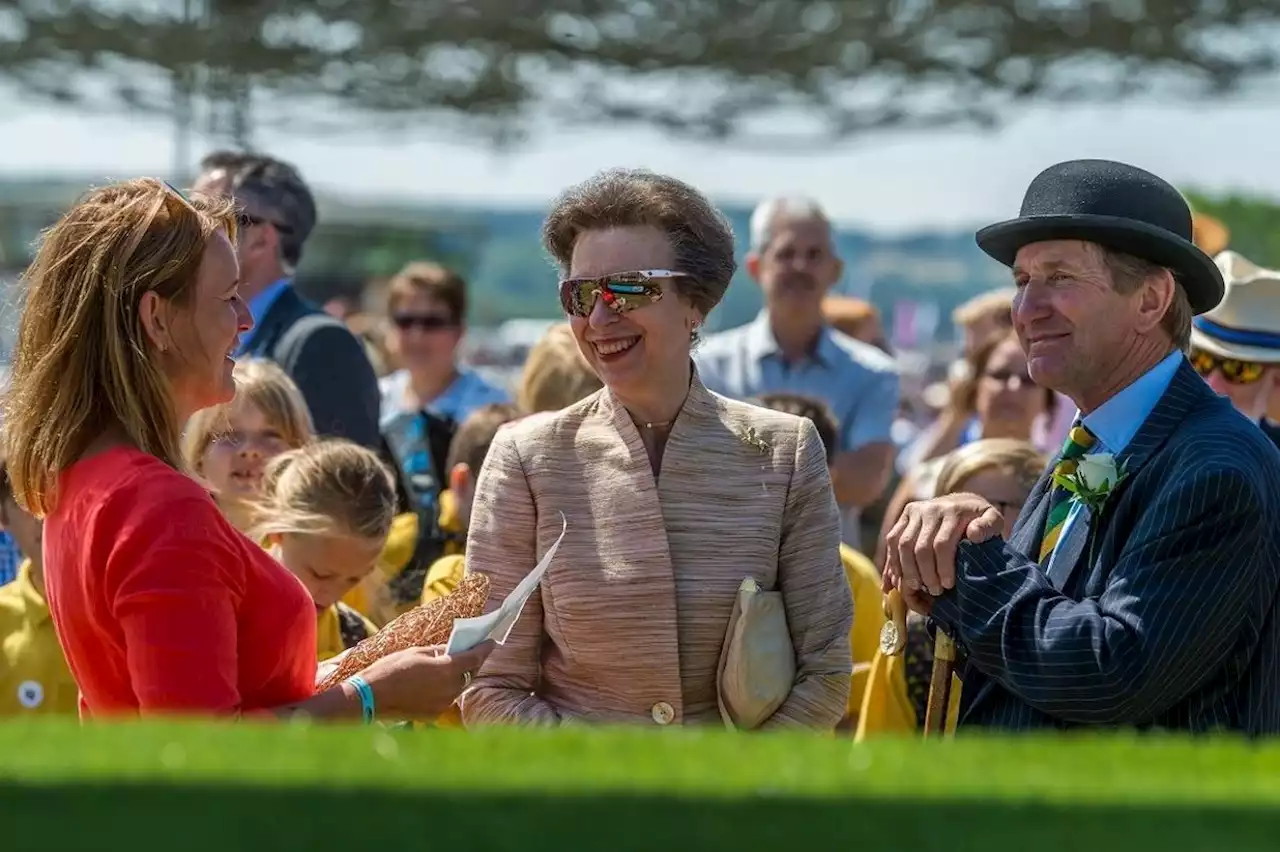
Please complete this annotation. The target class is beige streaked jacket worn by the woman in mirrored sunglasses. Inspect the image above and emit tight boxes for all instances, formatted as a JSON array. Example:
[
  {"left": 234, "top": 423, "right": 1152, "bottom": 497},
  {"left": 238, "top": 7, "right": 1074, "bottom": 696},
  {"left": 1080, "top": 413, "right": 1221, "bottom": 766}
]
[{"left": 462, "top": 376, "right": 852, "bottom": 729}]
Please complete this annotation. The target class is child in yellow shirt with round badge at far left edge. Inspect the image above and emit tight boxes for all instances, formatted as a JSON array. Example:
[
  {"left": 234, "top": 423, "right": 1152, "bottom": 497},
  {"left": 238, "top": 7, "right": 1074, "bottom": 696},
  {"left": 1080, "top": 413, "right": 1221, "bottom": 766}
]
[{"left": 0, "top": 447, "right": 79, "bottom": 716}]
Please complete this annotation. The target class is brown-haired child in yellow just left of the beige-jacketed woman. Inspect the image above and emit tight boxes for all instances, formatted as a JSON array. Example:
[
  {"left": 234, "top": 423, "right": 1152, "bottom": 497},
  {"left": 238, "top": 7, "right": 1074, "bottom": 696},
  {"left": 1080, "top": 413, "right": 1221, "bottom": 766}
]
[{"left": 422, "top": 403, "right": 520, "bottom": 604}]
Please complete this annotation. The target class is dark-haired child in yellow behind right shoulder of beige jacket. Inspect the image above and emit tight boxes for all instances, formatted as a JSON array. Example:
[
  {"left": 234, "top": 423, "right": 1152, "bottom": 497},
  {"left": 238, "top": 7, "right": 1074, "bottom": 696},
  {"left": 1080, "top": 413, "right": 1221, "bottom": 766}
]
[{"left": 753, "top": 393, "right": 884, "bottom": 730}]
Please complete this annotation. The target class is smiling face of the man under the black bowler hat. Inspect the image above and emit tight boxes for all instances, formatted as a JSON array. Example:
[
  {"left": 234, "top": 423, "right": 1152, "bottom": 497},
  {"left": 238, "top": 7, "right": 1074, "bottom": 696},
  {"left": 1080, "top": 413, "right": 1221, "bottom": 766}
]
[{"left": 1014, "top": 241, "right": 1162, "bottom": 404}]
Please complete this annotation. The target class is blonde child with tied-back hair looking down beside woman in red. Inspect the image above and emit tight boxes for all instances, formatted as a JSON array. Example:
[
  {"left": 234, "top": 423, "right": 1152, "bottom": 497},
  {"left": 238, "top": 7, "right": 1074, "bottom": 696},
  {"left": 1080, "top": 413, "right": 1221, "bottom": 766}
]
[{"left": 252, "top": 440, "right": 396, "bottom": 663}]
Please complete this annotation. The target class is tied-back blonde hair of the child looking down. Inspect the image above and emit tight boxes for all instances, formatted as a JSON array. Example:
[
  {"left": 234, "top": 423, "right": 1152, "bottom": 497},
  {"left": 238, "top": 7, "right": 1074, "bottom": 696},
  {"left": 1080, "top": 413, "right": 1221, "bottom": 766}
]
[{"left": 251, "top": 439, "right": 396, "bottom": 541}]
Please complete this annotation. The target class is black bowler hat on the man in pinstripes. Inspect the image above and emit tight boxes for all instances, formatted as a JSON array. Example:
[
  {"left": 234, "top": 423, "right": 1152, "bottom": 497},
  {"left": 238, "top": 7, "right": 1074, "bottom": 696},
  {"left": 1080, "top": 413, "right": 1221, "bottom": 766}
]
[{"left": 978, "top": 160, "right": 1224, "bottom": 313}]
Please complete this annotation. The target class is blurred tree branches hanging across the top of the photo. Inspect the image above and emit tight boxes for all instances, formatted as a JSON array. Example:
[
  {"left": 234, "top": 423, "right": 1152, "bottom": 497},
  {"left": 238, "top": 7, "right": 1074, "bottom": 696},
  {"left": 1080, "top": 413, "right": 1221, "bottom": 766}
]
[{"left": 0, "top": 0, "right": 1280, "bottom": 147}]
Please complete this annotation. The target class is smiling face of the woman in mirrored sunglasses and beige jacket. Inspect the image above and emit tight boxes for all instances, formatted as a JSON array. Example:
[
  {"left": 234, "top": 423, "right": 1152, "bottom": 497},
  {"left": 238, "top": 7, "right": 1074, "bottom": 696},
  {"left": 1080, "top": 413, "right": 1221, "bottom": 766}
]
[{"left": 568, "top": 226, "right": 703, "bottom": 397}]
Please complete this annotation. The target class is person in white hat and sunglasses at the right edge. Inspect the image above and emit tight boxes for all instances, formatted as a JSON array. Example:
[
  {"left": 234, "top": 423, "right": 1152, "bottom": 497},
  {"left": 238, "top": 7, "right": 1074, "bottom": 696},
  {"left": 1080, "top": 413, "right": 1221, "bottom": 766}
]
[{"left": 1190, "top": 252, "right": 1280, "bottom": 445}]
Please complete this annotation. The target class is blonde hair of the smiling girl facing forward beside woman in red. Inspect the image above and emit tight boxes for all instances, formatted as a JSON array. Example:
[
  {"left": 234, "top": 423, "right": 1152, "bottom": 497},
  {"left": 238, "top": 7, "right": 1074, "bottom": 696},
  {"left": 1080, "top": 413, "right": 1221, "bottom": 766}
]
[{"left": 182, "top": 358, "right": 315, "bottom": 475}]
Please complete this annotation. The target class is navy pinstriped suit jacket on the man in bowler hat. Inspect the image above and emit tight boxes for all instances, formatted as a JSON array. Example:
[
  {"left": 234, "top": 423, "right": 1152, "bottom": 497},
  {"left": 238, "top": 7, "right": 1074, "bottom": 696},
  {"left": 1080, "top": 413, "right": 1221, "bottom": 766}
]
[{"left": 933, "top": 361, "right": 1280, "bottom": 736}]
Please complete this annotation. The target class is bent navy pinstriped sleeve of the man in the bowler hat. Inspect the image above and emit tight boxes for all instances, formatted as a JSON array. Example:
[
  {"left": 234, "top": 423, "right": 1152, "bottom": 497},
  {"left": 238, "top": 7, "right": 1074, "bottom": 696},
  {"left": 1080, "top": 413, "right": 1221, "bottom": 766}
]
[{"left": 933, "top": 460, "right": 1274, "bottom": 725}]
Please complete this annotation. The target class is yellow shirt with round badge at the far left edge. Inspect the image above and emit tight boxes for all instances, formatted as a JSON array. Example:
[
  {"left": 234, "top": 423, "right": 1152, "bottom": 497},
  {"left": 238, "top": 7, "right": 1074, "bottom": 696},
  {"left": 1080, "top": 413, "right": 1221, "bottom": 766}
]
[{"left": 0, "top": 559, "right": 79, "bottom": 716}]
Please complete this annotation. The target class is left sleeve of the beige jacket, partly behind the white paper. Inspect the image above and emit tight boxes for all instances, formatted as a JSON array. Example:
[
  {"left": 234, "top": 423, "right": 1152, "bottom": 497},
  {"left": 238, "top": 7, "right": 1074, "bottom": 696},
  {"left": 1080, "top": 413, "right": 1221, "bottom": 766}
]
[{"left": 462, "top": 431, "right": 561, "bottom": 728}]
